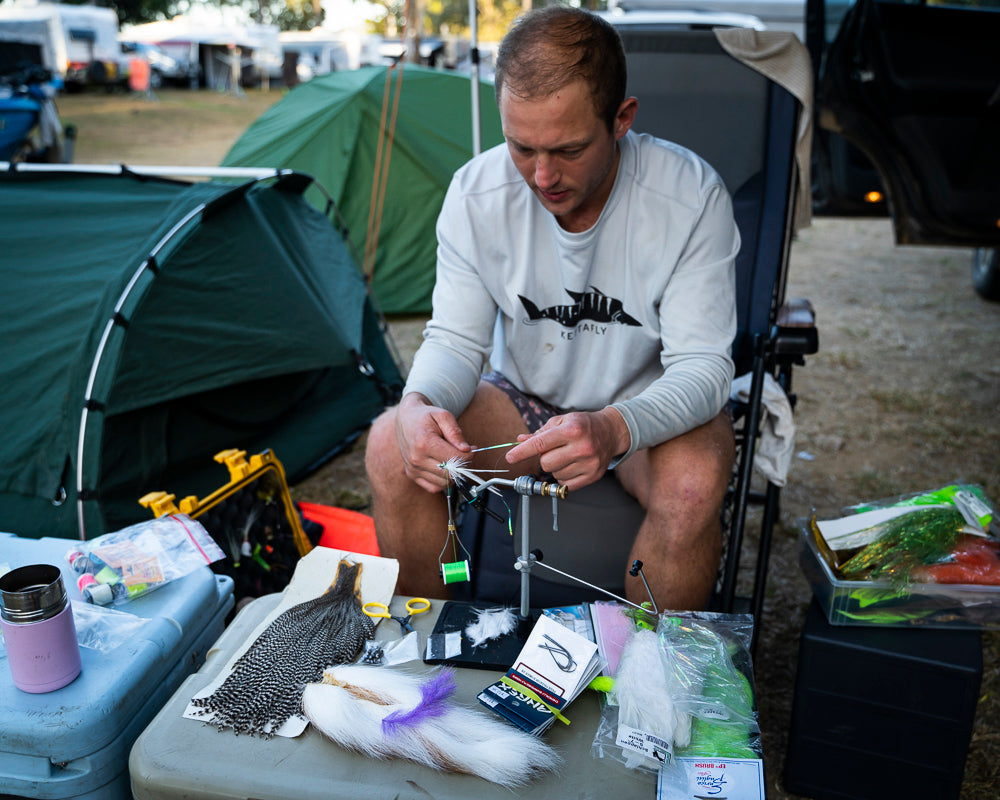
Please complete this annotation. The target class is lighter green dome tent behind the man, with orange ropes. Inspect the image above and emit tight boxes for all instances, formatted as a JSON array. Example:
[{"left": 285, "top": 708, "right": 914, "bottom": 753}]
[{"left": 222, "top": 64, "right": 503, "bottom": 314}]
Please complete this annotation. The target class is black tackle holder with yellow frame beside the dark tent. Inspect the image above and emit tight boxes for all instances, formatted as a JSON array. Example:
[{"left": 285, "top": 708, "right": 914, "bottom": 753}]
[{"left": 139, "top": 449, "right": 313, "bottom": 601}]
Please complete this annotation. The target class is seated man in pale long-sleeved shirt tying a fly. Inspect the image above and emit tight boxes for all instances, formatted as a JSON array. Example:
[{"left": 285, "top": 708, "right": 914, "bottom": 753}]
[{"left": 366, "top": 7, "right": 739, "bottom": 609}]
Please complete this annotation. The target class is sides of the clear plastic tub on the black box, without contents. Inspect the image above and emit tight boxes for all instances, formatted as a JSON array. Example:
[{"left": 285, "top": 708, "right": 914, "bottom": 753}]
[{"left": 799, "top": 520, "right": 1000, "bottom": 629}]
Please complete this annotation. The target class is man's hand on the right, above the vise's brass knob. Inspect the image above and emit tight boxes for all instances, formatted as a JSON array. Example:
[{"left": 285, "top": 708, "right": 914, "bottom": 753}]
[{"left": 507, "top": 407, "right": 631, "bottom": 491}]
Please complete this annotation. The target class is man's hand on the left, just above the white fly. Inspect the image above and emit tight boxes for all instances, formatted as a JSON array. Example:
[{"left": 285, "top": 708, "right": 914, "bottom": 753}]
[{"left": 396, "top": 393, "right": 472, "bottom": 492}]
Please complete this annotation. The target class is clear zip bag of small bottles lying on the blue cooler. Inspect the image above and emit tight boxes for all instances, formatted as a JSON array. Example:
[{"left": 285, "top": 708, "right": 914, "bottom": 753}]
[{"left": 66, "top": 514, "right": 225, "bottom": 606}]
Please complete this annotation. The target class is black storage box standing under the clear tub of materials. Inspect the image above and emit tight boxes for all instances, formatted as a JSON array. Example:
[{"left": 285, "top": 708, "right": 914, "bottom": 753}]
[{"left": 785, "top": 602, "right": 983, "bottom": 800}]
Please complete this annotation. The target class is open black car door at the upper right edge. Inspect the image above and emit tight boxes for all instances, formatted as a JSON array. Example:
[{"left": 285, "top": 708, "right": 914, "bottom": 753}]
[{"left": 806, "top": 0, "right": 1000, "bottom": 300}]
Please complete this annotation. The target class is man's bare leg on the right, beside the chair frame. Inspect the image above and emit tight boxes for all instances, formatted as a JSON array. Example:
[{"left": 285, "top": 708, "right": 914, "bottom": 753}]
[{"left": 618, "top": 413, "right": 735, "bottom": 610}]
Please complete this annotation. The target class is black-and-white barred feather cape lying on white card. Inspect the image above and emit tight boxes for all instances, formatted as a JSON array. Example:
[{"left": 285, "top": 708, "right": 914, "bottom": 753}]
[{"left": 191, "top": 561, "right": 375, "bottom": 738}]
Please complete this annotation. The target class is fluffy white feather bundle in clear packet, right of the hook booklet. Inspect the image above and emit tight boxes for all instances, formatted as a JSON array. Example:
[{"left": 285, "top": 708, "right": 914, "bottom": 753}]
[{"left": 615, "top": 628, "right": 691, "bottom": 766}]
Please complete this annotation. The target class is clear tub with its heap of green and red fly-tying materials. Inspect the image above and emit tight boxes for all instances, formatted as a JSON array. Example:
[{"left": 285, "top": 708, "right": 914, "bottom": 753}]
[{"left": 799, "top": 483, "right": 1000, "bottom": 629}]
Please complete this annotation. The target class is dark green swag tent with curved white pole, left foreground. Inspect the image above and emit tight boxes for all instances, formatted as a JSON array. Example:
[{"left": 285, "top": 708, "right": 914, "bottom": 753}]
[{"left": 0, "top": 166, "right": 401, "bottom": 538}]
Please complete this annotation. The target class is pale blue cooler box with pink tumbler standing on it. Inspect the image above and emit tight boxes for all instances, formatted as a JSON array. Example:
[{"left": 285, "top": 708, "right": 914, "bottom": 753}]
[{"left": 0, "top": 533, "right": 233, "bottom": 800}]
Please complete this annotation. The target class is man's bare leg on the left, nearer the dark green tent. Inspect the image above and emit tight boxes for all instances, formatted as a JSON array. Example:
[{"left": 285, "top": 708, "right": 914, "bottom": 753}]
[{"left": 365, "top": 383, "right": 537, "bottom": 598}]
